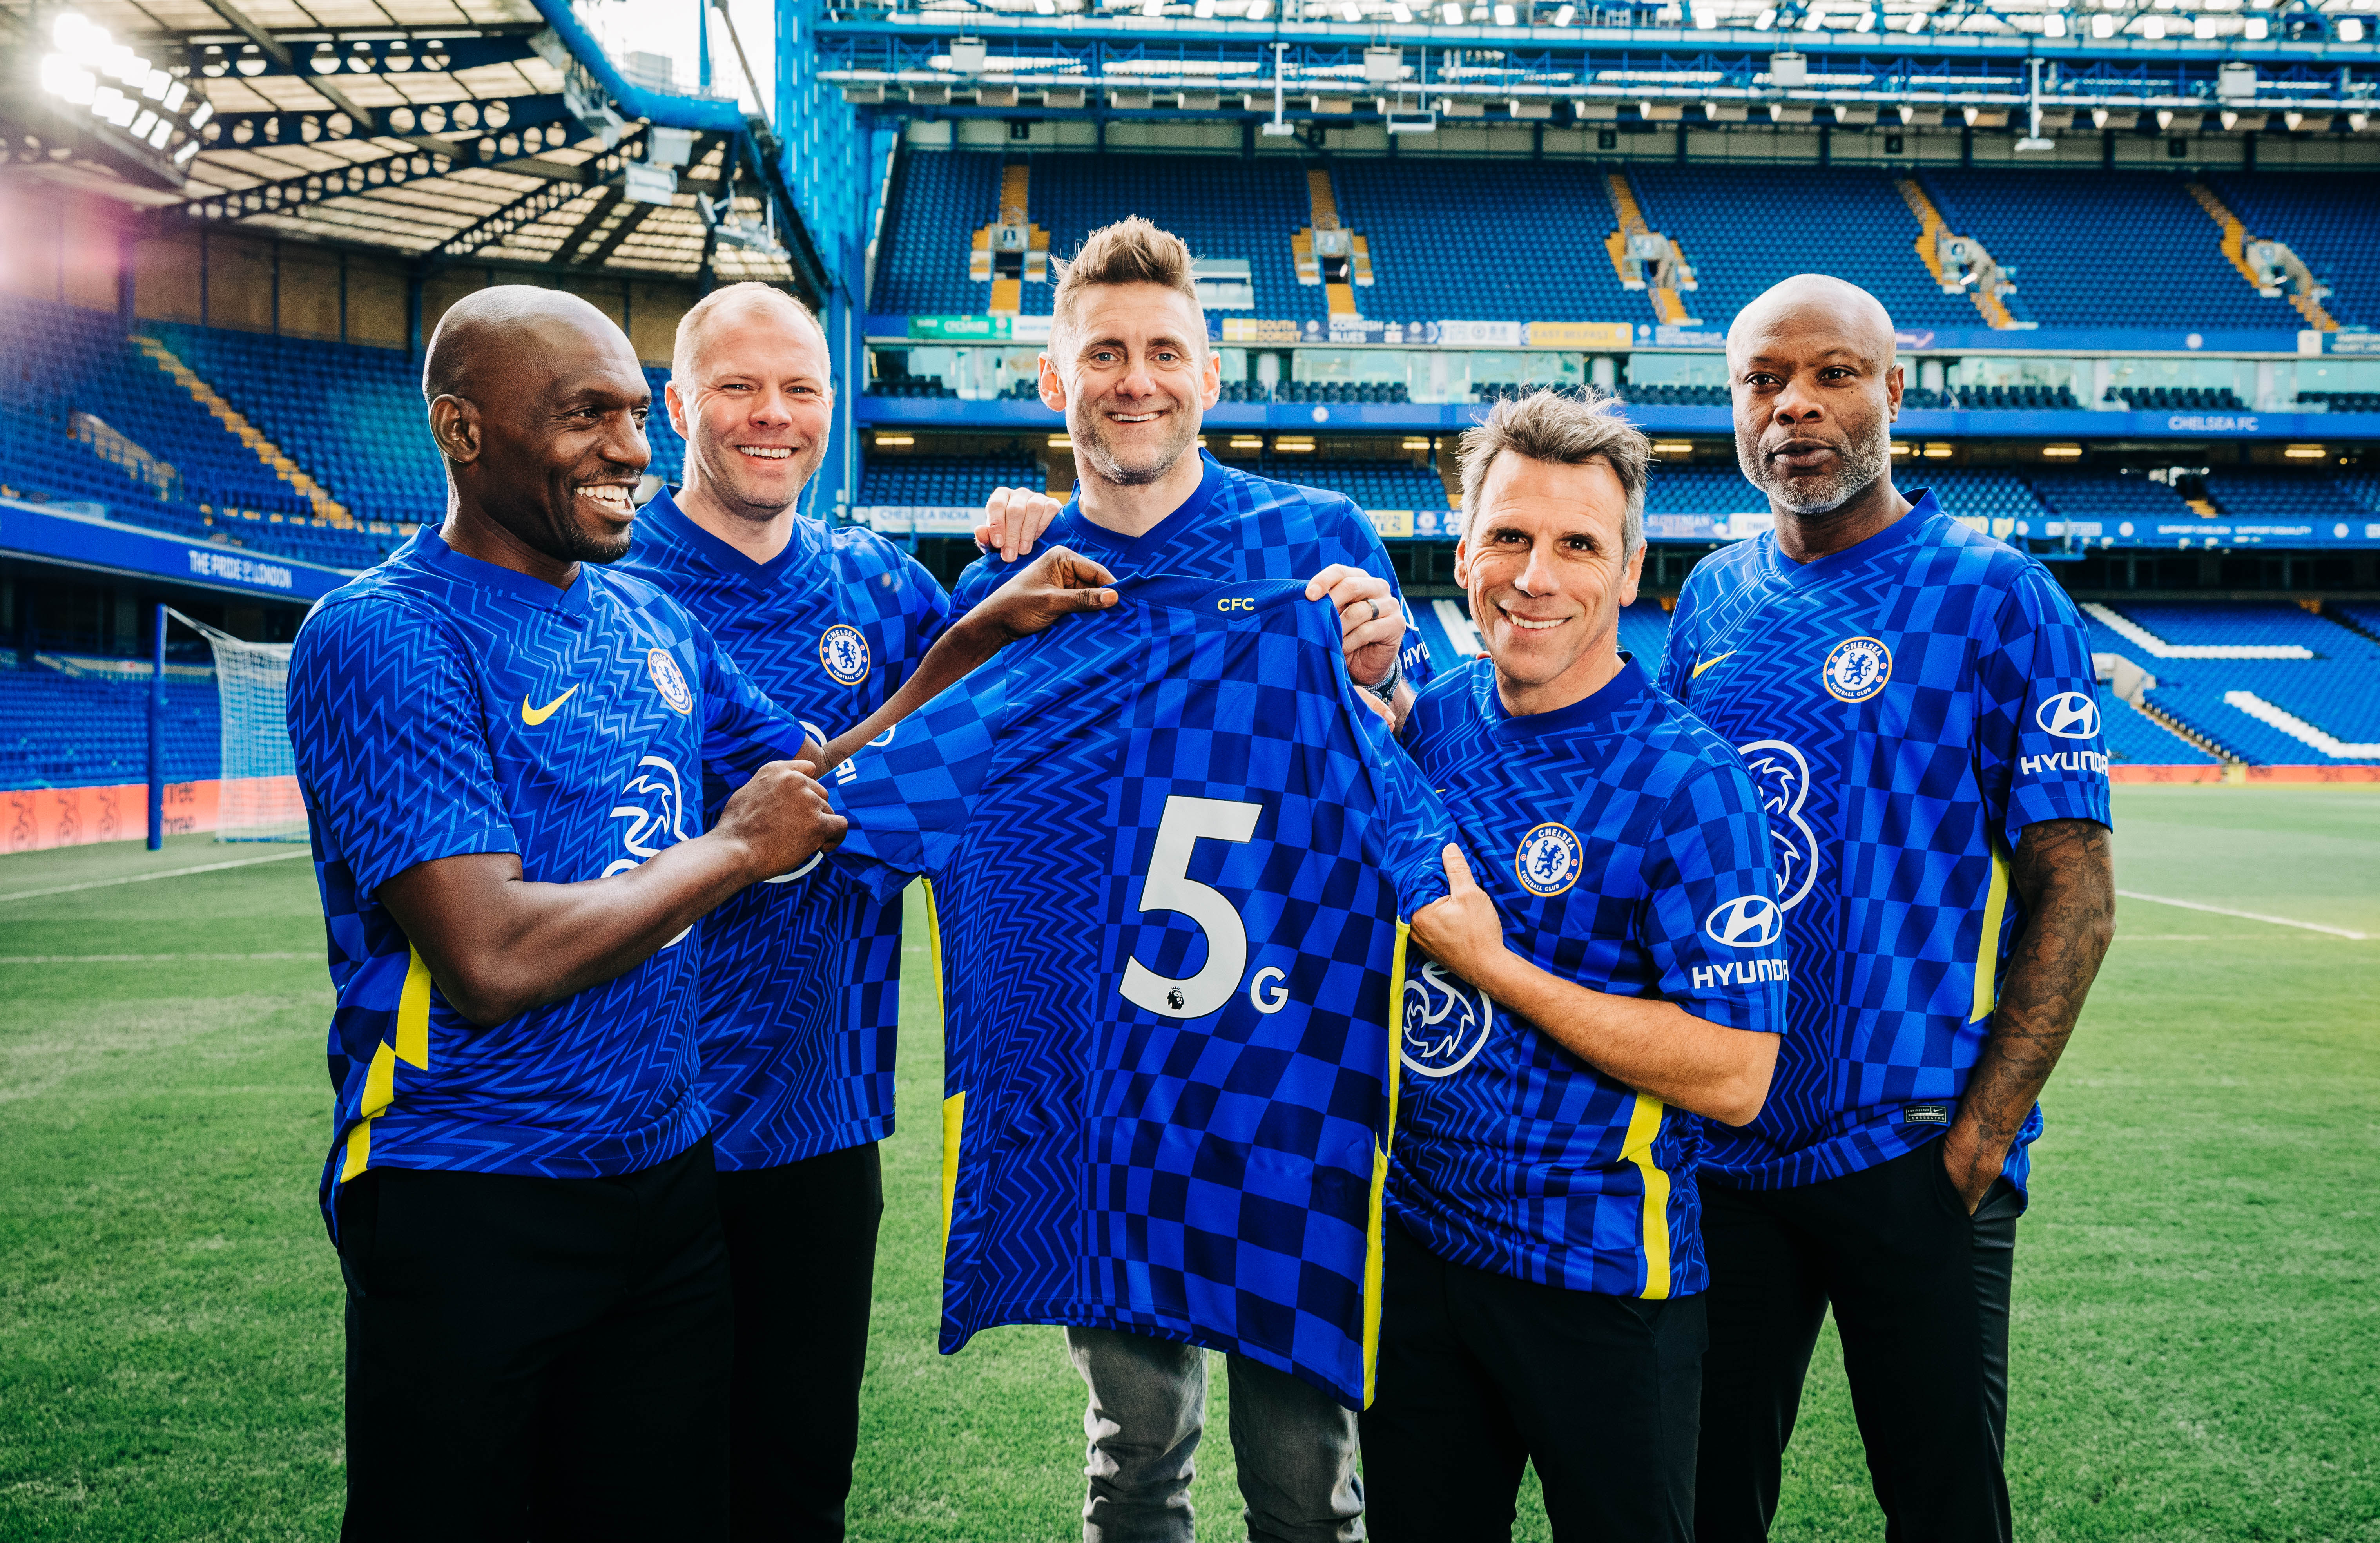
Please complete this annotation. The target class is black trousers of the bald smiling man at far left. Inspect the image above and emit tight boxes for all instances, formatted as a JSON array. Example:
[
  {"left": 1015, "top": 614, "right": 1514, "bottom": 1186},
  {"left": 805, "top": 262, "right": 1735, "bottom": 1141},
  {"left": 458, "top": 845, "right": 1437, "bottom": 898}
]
[{"left": 338, "top": 1141, "right": 733, "bottom": 1543}]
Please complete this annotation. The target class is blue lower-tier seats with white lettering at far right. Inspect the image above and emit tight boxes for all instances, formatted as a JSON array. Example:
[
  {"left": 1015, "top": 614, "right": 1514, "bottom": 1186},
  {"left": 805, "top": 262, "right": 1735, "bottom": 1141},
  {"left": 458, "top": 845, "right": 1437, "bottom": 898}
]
[{"left": 2083, "top": 603, "right": 2380, "bottom": 764}]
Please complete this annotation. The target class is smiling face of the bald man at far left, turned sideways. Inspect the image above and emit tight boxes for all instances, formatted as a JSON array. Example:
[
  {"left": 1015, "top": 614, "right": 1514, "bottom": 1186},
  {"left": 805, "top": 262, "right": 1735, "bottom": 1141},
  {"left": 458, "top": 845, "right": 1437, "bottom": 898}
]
[{"left": 431, "top": 302, "right": 652, "bottom": 562}]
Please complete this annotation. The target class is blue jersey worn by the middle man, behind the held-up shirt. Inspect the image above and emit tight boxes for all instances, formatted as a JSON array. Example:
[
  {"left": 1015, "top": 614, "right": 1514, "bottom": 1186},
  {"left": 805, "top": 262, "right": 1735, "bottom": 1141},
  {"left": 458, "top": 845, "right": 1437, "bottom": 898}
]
[{"left": 952, "top": 450, "right": 1430, "bottom": 686}]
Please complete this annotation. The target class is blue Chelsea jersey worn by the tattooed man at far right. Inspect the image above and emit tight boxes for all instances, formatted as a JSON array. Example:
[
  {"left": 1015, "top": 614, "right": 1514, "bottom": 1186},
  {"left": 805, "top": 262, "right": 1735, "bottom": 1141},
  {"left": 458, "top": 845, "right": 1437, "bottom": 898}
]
[{"left": 1661, "top": 493, "right": 2109, "bottom": 1188}]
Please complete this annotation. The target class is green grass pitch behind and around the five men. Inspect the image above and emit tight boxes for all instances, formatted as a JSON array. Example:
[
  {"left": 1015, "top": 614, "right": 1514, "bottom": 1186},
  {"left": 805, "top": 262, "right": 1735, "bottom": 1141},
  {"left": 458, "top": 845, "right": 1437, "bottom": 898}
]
[{"left": 0, "top": 788, "right": 2380, "bottom": 1543}]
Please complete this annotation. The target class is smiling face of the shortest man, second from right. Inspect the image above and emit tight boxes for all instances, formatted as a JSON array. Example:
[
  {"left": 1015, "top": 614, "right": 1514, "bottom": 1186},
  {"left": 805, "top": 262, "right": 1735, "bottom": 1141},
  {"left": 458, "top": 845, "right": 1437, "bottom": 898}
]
[{"left": 1454, "top": 450, "right": 1644, "bottom": 714}]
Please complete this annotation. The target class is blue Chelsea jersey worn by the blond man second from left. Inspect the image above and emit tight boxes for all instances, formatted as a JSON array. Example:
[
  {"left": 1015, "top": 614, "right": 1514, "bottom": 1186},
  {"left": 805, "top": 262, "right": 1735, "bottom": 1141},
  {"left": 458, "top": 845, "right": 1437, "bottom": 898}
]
[{"left": 616, "top": 491, "right": 950, "bottom": 1169}]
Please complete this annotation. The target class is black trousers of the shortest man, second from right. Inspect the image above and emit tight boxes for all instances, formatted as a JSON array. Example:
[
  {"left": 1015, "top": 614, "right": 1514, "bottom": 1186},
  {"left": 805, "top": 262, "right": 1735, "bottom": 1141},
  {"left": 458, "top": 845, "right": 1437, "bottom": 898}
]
[{"left": 1361, "top": 1222, "right": 1704, "bottom": 1543}]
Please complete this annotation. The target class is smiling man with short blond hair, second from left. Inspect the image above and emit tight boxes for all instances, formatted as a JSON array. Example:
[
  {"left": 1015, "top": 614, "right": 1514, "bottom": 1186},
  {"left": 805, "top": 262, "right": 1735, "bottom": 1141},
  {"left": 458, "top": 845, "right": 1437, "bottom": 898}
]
[{"left": 619, "top": 283, "right": 1057, "bottom": 1541}]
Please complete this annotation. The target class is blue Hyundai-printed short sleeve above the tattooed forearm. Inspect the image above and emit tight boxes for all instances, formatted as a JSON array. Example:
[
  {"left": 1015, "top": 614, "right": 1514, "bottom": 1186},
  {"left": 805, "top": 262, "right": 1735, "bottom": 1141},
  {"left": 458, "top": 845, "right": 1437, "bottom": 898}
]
[{"left": 1976, "top": 567, "right": 2114, "bottom": 850}]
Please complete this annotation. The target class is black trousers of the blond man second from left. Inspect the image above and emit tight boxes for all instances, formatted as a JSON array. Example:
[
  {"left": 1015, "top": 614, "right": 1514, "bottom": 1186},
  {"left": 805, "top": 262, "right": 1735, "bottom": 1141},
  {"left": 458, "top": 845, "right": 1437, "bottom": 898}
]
[{"left": 719, "top": 1141, "right": 885, "bottom": 1543}]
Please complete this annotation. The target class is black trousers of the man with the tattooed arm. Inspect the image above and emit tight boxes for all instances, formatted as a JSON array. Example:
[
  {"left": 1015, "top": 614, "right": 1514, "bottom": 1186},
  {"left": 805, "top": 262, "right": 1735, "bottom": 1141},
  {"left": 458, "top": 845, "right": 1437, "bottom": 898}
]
[{"left": 1695, "top": 1143, "right": 2021, "bottom": 1543}]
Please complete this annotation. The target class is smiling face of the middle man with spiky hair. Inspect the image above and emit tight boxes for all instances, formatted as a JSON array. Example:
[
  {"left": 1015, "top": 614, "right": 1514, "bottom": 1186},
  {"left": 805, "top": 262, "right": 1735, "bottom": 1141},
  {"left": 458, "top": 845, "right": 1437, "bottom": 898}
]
[{"left": 1042, "top": 283, "right": 1224, "bottom": 488}]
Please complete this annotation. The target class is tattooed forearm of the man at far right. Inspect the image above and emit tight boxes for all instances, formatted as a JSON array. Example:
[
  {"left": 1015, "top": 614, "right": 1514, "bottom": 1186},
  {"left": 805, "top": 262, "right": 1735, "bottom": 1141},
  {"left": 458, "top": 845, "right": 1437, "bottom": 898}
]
[{"left": 1942, "top": 819, "right": 2116, "bottom": 1210}]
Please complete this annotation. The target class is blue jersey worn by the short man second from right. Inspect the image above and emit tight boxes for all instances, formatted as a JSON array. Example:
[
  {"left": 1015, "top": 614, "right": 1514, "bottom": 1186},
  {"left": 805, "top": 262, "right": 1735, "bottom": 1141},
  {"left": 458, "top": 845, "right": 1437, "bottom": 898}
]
[{"left": 1390, "top": 659, "right": 1787, "bottom": 1298}]
